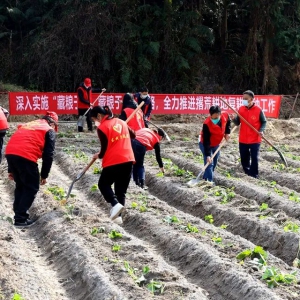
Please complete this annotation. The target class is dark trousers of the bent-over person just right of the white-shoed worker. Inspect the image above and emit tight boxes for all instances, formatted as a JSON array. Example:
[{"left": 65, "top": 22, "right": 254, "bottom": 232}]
[{"left": 131, "top": 139, "right": 146, "bottom": 184}]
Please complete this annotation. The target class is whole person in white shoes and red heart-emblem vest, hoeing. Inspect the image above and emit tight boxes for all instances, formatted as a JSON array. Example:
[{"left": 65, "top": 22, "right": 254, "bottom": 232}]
[{"left": 91, "top": 106, "right": 135, "bottom": 224}]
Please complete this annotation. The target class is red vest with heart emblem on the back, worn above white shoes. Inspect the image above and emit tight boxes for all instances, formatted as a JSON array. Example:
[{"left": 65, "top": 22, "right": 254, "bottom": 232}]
[{"left": 98, "top": 117, "right": 135, "bottom": 168}]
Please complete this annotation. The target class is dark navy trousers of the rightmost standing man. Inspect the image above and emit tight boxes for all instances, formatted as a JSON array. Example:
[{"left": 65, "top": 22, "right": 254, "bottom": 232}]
[{"left": 239, "top": 143, "right": 260, "bottom": 178}]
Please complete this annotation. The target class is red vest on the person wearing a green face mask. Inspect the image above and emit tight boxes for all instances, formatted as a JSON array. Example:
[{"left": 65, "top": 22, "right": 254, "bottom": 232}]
[{"left": 200, "top": 113, "right": 229, "bottom": 147}]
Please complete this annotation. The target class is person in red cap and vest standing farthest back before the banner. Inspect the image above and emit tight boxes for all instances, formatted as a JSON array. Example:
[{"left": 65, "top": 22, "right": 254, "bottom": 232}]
[{"left": 77, "top": 78, "right": 101, "bottom": 132}]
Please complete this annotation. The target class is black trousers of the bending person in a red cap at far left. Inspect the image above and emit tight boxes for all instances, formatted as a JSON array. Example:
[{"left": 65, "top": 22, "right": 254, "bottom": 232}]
[{"left": 6, "top": 155, "right": 40, "bottom": 222}]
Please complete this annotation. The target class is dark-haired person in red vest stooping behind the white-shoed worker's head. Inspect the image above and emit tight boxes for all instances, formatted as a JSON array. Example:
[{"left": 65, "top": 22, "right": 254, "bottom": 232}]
[{"left": 119, "top": 93, "right": 145, "bottom": 131}]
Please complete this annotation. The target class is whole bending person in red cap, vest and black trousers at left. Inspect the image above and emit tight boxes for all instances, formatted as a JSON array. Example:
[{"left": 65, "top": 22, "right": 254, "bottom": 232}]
[{"left": 5, "top": 111, "right": 58, "bottom": 226}]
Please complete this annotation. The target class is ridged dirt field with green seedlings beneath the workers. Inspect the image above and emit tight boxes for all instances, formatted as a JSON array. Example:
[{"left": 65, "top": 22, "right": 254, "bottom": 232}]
[{"left": 0, "top": 119, "right": 300, "bottom": 300}]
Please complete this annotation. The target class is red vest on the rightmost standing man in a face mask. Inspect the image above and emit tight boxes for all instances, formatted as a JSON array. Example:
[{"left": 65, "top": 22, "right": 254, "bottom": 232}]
[{"left": 239, "top": 105, "right": 261, "bottom": 144}]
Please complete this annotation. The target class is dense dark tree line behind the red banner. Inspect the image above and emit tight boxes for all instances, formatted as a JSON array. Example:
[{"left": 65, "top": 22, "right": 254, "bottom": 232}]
[{"left": 0, "top": 0, "right": 300, "bottom": 94}]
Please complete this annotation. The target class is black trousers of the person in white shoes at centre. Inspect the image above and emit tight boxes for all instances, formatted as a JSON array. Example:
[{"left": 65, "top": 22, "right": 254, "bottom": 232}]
[{"left": 98, "top": 162, "right": 132, "bottom": 206}]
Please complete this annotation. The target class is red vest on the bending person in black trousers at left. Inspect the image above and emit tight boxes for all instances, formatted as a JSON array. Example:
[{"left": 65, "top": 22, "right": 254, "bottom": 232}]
[{"left": 5, "top": 120, "right": 53, "bottom": 162}]
